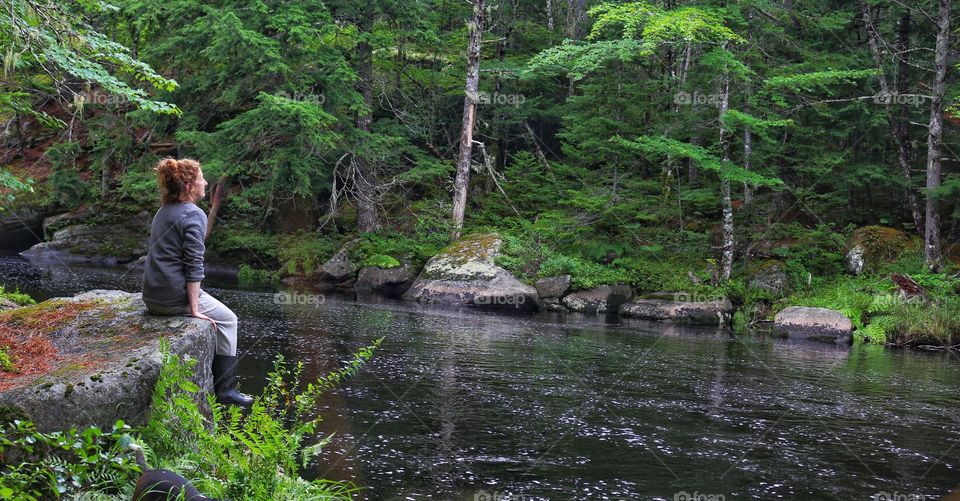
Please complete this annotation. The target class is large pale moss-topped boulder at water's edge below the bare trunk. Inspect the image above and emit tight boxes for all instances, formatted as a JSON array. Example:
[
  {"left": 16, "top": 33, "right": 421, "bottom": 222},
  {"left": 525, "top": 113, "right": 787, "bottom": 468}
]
[{"left": 403, "top": 233, "right": 543, "bottom": 311}]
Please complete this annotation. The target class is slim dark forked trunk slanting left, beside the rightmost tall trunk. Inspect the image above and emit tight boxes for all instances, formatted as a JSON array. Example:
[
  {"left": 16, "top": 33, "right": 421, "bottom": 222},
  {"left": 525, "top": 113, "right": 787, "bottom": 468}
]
[{"left": 860, "top": 0, "right": 923, "bottom": 234}]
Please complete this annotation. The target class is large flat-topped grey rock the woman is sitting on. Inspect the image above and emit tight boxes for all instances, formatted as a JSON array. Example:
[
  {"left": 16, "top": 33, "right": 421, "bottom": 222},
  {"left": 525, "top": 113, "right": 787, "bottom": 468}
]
[{"left": 0, "top": 290, "right": 215, "bottom": 431}]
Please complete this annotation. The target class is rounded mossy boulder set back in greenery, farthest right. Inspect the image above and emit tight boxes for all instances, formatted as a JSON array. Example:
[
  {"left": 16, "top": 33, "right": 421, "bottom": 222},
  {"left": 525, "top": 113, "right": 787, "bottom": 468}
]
[{"left": 844, "top": 226, "right": 921, "bottom": 275}]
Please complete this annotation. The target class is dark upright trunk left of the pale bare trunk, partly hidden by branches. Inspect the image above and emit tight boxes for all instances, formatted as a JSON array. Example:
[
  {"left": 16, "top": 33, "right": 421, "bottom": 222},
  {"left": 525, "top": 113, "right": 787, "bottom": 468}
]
[{"left": 354, "top": 10, "right": 380, "bottom": 232}]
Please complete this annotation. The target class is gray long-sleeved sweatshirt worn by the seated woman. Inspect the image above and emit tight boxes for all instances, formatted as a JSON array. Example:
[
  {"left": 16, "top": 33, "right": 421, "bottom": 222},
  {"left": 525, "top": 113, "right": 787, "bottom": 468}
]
[{"left": 143, "top": 202, "right": 207, "bottom": 305}]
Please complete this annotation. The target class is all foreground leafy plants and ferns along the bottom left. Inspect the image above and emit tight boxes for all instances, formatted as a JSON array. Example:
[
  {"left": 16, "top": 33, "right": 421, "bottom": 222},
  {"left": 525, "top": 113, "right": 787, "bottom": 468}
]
[{"left": 0, "top": 341, "right": 379, "bottom": 501}]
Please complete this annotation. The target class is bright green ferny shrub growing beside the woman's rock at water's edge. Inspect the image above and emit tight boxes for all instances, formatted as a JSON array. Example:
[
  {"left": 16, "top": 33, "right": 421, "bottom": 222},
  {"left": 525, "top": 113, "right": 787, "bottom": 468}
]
[{"left": 140, "top": 338, "right": 382, "bottom": 500}]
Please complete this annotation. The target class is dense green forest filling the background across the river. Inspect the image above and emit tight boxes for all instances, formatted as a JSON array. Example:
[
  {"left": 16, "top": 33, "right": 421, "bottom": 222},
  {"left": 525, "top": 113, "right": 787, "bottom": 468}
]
[{"left": 0, "top": 0, "right": 960, "bottom": 345}]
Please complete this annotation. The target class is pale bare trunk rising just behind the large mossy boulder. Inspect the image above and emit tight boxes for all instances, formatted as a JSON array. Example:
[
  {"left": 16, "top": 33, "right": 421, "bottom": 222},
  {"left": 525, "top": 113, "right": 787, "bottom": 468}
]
[{"left": 450, "top": 0, "right": 485, "bottom": 238}]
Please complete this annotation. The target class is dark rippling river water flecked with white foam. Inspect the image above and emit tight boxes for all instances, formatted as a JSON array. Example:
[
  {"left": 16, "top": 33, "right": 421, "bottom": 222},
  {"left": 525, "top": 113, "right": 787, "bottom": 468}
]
[{"left": 0, "top": 258, "right": 960, "bottom": 501}]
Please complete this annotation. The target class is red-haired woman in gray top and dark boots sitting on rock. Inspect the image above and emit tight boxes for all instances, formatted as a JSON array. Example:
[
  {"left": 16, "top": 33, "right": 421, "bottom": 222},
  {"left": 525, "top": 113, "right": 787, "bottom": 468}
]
[{"left": 143, "top": 158, "right": 253, "bottom": 406}]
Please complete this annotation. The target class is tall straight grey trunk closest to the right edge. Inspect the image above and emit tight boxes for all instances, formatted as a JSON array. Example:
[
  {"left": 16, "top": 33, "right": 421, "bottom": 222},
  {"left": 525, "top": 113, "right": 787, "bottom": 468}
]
[{"left": 924, "top": 0, "right": 950, "bottom": 272}]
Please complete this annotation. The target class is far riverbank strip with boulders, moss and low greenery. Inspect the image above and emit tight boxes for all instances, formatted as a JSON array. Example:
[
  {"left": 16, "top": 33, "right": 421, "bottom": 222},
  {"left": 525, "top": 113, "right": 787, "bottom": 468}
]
[{"left": 3, "top": 202, "right": 960, "bottom": 348}]
